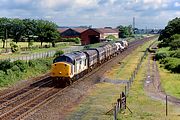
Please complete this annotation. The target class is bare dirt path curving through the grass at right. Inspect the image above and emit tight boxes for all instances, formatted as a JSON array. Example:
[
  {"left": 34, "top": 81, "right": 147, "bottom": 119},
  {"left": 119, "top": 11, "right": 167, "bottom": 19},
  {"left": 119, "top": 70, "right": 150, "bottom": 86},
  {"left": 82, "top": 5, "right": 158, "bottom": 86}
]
[{"left": 144, "top": 53, "right": 180, "bottom": 106}]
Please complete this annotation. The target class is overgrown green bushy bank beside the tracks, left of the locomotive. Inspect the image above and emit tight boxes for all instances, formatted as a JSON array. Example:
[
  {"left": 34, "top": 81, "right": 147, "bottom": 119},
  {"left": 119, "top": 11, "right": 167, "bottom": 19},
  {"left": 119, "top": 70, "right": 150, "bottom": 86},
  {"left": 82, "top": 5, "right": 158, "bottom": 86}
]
[{"left": 0, "top": 58, "right": 52, "bottom": 88}]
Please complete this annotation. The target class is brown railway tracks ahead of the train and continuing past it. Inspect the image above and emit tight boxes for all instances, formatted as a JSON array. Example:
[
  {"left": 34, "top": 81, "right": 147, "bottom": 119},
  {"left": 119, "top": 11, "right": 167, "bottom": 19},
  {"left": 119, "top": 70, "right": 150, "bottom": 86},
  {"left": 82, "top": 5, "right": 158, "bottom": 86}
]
[{"left": 0, "top": 36, "right": 156, "bottom": 120}]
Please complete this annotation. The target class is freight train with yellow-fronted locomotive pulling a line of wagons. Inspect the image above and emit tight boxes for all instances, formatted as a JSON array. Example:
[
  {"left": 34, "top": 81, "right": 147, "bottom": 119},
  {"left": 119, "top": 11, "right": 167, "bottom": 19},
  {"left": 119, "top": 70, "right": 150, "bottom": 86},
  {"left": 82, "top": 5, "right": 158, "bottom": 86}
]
[{"left": 51, "top": 40, "right": 128, "bottom": 85}]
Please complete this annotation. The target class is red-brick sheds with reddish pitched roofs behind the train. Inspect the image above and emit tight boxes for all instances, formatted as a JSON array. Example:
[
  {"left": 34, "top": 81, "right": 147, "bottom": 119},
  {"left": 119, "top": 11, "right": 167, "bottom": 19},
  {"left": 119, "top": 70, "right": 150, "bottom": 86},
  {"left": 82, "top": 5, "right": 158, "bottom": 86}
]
[{"left": 59, "top": 28, "right": 119, "bottom": 45}]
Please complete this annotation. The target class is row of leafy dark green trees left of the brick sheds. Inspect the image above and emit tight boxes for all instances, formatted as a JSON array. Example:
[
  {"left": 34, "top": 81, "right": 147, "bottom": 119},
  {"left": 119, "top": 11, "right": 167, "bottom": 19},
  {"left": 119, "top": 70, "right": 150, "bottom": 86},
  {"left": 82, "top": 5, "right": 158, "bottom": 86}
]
[{"left": 0, "top": 18, "right": 60, "bottom": 48}]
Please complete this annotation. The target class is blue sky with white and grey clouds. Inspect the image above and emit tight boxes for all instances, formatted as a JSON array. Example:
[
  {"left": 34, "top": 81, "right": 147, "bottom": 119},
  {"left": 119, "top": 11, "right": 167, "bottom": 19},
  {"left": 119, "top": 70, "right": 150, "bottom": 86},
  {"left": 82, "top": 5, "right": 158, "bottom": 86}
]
[{"left": 0, "top": 0, "right": 180, "bottom": 29}]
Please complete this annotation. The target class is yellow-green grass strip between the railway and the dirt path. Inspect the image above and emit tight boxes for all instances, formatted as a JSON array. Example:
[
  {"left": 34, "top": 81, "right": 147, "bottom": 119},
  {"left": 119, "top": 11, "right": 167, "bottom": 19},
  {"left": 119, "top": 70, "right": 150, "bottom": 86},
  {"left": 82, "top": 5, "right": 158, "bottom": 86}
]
[{"left": 67, "top": 38, "right": 180, "bottom": 120}]
